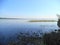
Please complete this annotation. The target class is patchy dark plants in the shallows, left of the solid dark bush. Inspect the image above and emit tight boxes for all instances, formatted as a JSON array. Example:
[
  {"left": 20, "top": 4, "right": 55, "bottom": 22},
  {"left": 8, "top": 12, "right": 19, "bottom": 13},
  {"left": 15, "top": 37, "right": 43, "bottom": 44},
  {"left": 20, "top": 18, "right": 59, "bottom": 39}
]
[{"left": 8, "top": 32, "right": 42, "bottom": 45}]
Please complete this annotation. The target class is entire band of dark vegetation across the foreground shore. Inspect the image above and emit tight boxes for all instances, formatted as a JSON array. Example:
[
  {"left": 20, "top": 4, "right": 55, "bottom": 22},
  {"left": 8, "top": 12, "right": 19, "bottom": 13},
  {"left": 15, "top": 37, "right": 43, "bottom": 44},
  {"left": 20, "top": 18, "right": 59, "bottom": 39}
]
[{"left": 0, "top": 29, "right": 60, "bottom": 45}]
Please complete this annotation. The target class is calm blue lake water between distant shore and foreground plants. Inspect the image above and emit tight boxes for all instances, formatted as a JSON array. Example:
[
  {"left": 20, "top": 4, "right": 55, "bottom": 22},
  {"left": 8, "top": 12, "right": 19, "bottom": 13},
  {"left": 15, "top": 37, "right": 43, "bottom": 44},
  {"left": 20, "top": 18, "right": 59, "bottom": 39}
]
[{"left": 0, "top": 20, "right": 58, "bottom": 36}]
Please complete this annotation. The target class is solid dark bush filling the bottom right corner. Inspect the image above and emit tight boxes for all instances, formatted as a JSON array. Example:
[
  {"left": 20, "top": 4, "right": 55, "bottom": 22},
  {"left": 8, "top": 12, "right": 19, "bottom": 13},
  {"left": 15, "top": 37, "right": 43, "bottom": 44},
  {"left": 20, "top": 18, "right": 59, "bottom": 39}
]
[{"left": 43, "top": 29, "right": 60, "bottom": 45}]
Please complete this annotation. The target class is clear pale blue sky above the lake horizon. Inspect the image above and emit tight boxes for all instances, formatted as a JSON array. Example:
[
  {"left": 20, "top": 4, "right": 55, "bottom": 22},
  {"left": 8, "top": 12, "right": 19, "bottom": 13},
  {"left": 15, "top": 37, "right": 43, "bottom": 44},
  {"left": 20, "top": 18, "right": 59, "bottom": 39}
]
[{"left": 0, "top": 0, "right": 60, "bottom": 19}]
